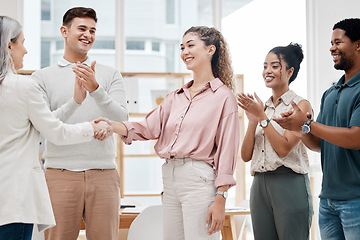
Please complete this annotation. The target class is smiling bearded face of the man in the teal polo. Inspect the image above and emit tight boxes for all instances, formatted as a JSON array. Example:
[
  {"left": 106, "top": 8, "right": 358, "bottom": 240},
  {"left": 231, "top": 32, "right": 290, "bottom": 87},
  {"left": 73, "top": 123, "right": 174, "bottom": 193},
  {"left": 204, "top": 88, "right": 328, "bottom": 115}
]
[{"left": 330, "top": 28, "right": 356, "bottom": 71}]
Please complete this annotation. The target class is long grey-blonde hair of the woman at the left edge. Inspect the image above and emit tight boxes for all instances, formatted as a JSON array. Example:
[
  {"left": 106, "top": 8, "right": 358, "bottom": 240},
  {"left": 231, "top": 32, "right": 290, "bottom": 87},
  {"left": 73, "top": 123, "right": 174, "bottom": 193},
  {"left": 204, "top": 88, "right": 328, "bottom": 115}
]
[{"left": 0, "top": 16, "right": 21, "bottom": 84}]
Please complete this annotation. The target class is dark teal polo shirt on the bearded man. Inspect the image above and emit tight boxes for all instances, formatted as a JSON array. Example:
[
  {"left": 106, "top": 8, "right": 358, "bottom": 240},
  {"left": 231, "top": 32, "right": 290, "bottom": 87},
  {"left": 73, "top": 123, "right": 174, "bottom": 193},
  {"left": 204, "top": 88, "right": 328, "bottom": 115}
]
[{"left": 317, "top": 72, "right": 360, "bottom": 200}]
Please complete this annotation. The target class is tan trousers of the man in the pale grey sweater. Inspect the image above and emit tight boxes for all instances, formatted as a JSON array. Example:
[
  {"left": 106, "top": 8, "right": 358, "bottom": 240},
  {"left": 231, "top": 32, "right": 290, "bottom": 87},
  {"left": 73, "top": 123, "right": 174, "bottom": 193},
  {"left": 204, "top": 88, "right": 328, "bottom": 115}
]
[{"left": 45, "top": 168, "right": 120, "bottom": 240}]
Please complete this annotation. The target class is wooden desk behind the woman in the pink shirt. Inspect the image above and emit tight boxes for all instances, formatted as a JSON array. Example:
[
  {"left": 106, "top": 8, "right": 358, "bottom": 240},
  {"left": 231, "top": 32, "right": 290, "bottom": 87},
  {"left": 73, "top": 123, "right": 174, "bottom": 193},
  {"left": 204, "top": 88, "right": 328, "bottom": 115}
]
[{"left": 81, "top": 208, "right": 250, "bottom": 240}]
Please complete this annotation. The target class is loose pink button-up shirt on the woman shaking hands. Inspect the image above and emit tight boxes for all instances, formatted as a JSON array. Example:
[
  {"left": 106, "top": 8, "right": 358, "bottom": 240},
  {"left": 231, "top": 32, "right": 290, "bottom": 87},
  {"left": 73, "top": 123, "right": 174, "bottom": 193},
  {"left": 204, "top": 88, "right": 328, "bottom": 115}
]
[{"left": 122, "top": 78, "right": 240, "bottom": 188}]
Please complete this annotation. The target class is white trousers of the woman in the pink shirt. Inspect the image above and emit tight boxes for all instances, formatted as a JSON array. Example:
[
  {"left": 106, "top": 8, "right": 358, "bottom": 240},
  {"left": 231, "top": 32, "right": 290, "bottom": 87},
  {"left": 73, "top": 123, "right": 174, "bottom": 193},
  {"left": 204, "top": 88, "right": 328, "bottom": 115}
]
[{"left": 162, "top": 158, "right": 220, "bottom": 240}]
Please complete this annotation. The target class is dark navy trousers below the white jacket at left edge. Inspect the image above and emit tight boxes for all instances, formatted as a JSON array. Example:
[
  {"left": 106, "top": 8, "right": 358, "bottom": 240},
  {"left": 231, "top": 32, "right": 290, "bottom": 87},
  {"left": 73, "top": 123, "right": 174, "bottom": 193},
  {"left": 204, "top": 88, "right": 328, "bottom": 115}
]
[{"left": 0, "top": 223, "right": 34, "bottom": 240}]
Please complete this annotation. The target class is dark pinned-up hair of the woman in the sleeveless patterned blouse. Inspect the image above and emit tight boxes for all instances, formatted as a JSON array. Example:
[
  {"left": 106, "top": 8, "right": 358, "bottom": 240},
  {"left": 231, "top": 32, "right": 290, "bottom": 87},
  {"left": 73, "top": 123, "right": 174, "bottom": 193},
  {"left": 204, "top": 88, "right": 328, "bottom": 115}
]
[{"left": 269, "top": 43, "right": 304, "bottom": 84}]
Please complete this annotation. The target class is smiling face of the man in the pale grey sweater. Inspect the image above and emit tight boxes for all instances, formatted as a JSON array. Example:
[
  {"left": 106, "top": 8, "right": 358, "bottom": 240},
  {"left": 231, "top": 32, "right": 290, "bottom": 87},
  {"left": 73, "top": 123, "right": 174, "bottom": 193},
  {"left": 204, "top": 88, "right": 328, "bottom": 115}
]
[{"left": 60, "top": 17, "right": 96, "bottom": 59}]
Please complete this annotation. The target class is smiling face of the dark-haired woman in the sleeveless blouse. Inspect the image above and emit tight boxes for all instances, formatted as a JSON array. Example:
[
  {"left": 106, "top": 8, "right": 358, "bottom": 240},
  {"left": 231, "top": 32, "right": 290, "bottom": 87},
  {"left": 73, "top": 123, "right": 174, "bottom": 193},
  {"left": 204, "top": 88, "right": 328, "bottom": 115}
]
[{"left": 263, "top": 52, "right": 293, "bottom": 89}]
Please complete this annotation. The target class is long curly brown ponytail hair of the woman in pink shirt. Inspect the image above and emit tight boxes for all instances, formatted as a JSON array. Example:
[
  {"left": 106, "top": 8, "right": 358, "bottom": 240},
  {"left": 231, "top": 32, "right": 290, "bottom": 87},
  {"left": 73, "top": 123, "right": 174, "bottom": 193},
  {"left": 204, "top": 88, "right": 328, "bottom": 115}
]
[{"left": 183, "top": 26, "right": 234, "bottom": 90}]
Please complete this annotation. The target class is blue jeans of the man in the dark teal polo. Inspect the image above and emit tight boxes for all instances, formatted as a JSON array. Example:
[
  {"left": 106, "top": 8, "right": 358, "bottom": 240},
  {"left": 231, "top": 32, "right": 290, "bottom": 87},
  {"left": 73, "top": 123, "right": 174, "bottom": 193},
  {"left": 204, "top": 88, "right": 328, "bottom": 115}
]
[{"left": 319, "top": 198, "right": 360, "bottom": 240}]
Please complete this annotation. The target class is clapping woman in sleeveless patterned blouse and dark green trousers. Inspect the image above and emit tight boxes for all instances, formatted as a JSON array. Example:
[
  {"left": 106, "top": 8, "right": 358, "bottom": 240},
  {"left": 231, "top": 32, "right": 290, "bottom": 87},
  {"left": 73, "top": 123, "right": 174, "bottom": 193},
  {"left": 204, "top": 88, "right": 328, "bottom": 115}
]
[{"left": 238, "top": 43, "right": 313, "bottom": 240}]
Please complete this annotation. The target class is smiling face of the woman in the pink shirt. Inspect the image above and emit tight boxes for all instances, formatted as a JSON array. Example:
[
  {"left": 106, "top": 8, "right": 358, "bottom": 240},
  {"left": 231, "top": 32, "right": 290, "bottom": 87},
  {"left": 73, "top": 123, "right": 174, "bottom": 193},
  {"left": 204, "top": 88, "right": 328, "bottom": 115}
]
[{"left": 180, "top": 33, "right": 215, "bottom": 71}]
